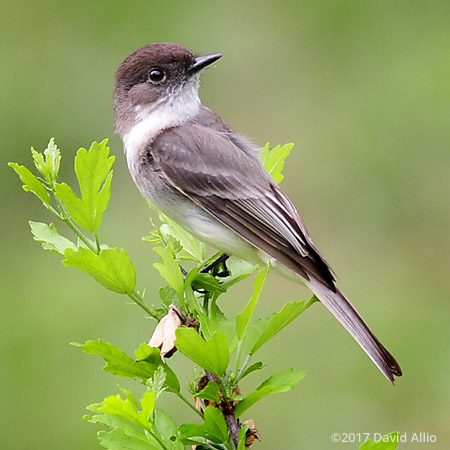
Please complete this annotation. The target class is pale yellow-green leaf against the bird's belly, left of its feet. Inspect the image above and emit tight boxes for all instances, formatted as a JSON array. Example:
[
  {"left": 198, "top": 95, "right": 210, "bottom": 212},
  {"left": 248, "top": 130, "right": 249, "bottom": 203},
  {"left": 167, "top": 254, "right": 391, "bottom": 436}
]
[{"left": 159, "top": 213, "right": 205, "bottom": 263}]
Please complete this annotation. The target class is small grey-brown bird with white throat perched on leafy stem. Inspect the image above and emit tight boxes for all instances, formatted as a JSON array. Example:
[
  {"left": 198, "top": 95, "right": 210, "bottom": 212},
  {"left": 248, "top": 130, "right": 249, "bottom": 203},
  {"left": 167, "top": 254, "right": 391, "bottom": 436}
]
[{"left": 114, "top": 43, "right": 402, "bottom": 383}]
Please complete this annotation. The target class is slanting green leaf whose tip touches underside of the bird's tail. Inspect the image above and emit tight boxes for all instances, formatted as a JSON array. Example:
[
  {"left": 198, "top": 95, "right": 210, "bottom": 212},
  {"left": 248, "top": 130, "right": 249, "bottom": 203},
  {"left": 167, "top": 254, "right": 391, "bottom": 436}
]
[{"left": 246, "top": 297, "right": 317, "bottom": 355}]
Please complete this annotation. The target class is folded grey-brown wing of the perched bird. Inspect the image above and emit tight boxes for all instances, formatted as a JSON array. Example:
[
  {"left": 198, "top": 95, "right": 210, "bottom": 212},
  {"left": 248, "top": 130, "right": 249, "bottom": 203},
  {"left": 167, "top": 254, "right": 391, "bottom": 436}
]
[{"left": 151, "top": 123, "right": 335, "bottom": 290}]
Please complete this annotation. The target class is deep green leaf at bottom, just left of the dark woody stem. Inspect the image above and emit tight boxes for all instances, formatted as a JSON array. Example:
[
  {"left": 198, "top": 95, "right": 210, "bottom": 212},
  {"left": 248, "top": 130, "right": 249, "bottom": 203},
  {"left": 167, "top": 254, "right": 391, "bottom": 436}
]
[{"left": 178, "top": 406, "right": 228, "bottom": 445}]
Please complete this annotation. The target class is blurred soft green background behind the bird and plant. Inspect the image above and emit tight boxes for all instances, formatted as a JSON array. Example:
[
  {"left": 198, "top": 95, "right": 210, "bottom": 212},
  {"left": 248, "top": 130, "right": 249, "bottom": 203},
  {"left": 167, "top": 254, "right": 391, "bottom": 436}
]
[{"left": 0, "top": 0, "right": 450, "bottom": 450}]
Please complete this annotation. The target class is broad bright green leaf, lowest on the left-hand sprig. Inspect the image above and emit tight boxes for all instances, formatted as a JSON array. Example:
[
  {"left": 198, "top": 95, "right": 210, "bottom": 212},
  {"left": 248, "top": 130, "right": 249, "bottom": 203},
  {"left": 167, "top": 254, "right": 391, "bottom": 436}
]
[{"left": 63, "top": 247, "right": 136, "bottom": 294}]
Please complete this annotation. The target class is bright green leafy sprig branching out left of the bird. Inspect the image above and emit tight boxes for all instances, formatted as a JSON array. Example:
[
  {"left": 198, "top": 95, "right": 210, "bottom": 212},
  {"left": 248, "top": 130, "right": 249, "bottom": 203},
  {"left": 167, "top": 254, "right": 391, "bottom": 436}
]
[{"left": 9, "top": 139, "right": 160, "bottom": 319}]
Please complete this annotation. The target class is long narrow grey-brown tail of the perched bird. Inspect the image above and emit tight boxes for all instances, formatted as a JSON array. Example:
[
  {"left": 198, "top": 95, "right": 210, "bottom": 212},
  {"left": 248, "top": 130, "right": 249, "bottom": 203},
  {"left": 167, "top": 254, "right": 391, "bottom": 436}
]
[{"left": 305, "top": 277, "right": 402, "bottom": 384}]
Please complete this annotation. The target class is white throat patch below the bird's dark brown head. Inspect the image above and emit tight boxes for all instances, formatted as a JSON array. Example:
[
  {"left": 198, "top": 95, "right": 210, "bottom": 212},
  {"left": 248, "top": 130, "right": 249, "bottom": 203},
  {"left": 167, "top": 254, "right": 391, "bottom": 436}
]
[{"left": 122, "top": 77, "right": 200, "bottom": 166}]
